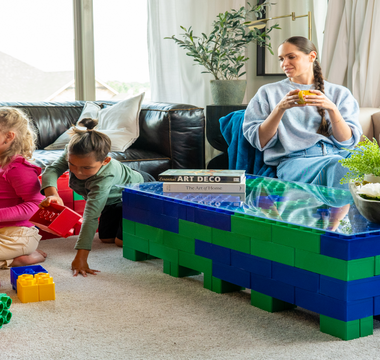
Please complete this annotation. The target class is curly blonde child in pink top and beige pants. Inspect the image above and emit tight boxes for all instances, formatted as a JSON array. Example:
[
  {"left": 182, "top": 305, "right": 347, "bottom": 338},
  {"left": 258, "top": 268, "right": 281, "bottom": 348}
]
[{"left": 0, "top": 107, "right": 46, "bottom": 269}]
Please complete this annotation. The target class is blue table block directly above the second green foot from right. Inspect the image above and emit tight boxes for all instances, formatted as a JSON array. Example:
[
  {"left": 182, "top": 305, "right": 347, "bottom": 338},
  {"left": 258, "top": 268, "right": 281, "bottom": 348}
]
[{"left": 251, "top": 273, "right": 295, "bottom": 304}]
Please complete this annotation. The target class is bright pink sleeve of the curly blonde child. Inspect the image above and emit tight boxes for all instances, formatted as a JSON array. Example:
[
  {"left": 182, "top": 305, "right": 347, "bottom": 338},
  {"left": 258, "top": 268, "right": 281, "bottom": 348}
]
[{"left": 0, "top": 166, "right": 44, "bottom": 222}]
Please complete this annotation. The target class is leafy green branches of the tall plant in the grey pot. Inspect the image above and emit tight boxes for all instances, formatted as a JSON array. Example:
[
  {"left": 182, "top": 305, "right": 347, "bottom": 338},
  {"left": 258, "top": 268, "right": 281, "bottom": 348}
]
[{"left": 165, "top": 1, "right": 280, "bottom": 80}]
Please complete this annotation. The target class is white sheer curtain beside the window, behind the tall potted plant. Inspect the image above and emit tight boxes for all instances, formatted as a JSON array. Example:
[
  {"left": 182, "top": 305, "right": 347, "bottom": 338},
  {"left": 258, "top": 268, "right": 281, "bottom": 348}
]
[{"left": 148, "top": 0, "right": 245, "bottom": 162}]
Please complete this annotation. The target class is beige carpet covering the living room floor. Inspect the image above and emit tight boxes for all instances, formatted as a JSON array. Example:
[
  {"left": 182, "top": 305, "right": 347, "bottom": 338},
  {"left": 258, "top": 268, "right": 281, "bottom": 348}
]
[{"left": 0, "top": 237, "right": 380, "bottom": 360}]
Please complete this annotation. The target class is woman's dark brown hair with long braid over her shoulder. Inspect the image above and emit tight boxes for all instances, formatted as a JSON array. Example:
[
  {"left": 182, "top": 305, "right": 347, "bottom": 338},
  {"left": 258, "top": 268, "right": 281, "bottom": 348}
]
[{"left": 283, "top": 36, "right": 330, "bottom": 137}]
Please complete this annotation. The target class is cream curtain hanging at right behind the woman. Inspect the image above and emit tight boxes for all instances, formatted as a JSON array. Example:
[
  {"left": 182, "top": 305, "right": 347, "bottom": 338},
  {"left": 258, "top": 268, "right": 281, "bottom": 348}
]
[{"left": 322, "top": 0, "right": 380, "bottom": 107}]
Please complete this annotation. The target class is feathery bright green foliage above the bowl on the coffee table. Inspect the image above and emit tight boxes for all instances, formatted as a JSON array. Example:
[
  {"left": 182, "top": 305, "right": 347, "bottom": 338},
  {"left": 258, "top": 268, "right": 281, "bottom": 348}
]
[{"left": 339, "top": 137, "right": 380, "bottom": 184}]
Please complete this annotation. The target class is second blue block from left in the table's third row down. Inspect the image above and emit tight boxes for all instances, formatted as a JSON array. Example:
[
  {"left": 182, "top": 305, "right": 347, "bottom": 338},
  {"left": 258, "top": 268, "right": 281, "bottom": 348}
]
[{"left": 231, "top": 250, "right": 272, "bottom": 278}]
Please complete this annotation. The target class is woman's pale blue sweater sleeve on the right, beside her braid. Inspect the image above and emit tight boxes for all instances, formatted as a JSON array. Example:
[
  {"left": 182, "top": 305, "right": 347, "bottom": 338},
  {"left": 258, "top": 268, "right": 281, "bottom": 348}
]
[{"left": 329, "top": 89, "right": 363, "bottom": 149}]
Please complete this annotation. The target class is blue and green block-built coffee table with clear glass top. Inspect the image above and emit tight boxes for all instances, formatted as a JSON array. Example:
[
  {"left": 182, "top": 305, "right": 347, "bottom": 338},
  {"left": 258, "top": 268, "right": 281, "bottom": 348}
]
[{"left": 123, "top": 177, "right": 380, "bottom": 340}]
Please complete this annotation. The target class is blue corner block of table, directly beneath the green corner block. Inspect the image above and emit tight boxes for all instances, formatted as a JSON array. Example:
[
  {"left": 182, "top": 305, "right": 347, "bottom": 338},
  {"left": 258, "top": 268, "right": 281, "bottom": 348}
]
[{"left": 320, "top": 275, "right": 380, "bottom": 301}]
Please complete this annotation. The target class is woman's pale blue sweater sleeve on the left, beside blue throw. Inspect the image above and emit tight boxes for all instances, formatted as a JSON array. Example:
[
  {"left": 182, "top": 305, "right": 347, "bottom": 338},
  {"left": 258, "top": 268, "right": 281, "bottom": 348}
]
[{"left": 243, "top": 88, "right": 277, "bottom": 151}]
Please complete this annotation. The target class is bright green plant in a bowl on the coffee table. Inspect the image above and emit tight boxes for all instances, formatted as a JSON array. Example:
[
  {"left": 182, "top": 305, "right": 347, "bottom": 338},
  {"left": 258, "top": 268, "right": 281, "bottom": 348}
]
[{"left": 339, "top": 137, "right": 380, "bottom": 224}]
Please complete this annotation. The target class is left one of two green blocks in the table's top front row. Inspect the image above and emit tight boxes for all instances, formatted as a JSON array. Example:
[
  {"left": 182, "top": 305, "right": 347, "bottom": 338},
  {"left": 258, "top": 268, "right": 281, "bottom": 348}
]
[{"left": 231, "top": 214, "right": 272, "bottom": 241}]
